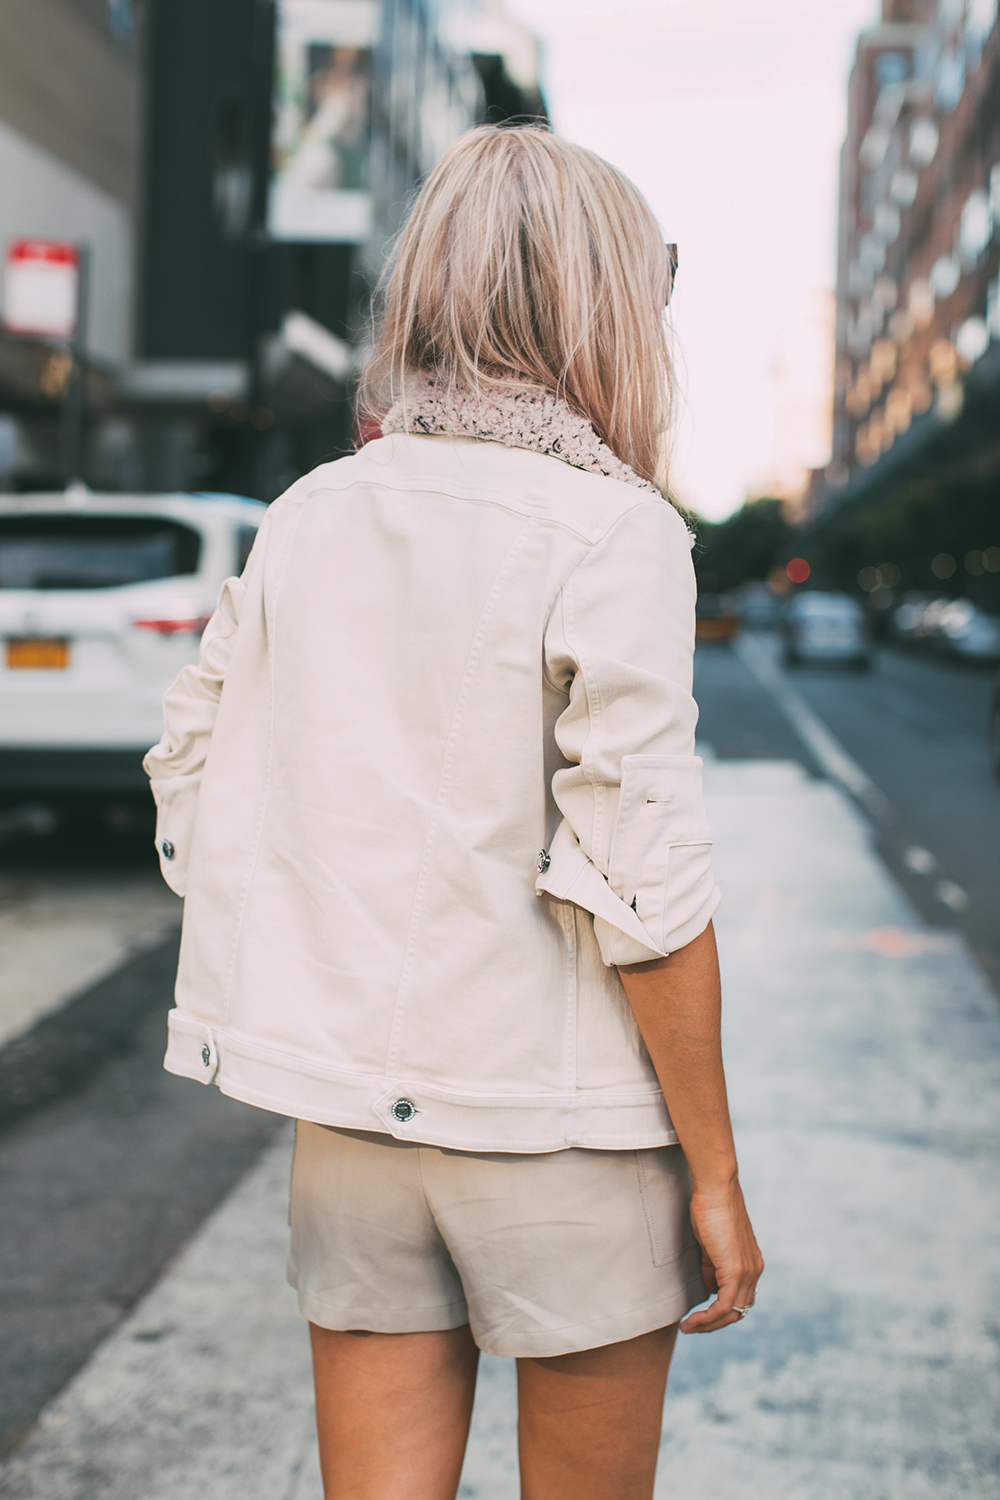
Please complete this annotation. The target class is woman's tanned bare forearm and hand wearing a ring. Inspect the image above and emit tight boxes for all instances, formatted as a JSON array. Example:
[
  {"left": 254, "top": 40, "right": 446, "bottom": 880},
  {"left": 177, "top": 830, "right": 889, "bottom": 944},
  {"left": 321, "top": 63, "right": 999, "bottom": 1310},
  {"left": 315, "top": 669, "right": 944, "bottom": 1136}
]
[{"left": 619, "top": 923, "right": 763, "bottom": 1334}]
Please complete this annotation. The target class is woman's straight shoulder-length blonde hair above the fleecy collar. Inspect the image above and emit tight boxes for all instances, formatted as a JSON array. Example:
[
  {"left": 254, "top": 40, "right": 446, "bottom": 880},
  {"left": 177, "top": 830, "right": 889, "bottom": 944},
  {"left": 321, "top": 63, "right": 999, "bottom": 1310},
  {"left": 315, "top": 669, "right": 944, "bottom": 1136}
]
[{"left": 358, "top": 125, "right": 672, "bottom": 489}]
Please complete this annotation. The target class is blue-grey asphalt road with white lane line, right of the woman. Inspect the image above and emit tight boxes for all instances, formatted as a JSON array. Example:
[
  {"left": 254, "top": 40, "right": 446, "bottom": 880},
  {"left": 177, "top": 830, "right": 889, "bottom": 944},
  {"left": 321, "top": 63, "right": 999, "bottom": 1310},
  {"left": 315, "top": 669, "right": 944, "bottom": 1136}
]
[{"left": 694, "top": 635, "right": 1000, "bottom": 993}]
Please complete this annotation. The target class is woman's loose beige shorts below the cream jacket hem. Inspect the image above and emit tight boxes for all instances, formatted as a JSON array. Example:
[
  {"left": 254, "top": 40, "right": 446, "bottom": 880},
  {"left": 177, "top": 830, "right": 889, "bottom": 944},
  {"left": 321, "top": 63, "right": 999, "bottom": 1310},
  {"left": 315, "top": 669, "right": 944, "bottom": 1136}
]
[{"left": 288, "top": 1121, "right": 706, "bottom": 1358}]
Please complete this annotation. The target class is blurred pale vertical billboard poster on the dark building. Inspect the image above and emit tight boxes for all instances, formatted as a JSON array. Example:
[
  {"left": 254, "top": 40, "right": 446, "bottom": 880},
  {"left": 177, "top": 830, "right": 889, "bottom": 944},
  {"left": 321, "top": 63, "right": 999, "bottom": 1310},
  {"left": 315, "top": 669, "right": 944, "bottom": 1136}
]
[{"left": 268, "top": 0, "right": 381, "bottom": 245}]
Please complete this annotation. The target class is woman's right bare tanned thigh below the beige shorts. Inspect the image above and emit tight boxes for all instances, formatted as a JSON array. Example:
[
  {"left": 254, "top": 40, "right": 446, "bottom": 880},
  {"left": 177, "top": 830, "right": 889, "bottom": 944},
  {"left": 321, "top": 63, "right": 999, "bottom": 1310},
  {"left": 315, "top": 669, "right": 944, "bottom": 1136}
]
[{"left": 517, "top": 1323, "right": 678, "bottom": 1500}]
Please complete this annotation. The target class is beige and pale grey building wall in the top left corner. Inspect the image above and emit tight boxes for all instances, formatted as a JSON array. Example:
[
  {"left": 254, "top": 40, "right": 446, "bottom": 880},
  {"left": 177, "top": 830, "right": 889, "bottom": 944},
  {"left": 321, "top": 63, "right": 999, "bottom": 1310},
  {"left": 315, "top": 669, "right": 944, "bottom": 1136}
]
[{"left": 0, "top": 0, "right": 142, "bottom": 488}]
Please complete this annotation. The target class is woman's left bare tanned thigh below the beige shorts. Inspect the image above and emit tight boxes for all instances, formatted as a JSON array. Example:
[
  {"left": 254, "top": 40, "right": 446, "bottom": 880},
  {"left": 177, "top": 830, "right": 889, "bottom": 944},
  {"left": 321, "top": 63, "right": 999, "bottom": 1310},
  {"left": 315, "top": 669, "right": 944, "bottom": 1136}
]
[{"left": 309, "top": 1323, "right": 480, "bottom": 1500}]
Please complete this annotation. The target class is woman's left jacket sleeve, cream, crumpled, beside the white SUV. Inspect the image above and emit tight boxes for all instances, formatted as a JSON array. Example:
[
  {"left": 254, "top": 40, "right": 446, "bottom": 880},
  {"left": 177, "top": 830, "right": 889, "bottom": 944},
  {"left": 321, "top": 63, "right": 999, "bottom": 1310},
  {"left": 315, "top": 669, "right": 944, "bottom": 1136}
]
[{"left": 142, "top": 522, "right": 267, "bottom": 896}]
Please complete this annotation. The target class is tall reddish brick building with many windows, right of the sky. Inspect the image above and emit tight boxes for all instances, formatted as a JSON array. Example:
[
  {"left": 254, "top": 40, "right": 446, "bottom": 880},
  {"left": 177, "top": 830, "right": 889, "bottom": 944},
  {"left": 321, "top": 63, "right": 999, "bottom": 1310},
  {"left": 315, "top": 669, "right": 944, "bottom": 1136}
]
[{"left": 814, "top": 0, "right": 1000, "bottom": 534}]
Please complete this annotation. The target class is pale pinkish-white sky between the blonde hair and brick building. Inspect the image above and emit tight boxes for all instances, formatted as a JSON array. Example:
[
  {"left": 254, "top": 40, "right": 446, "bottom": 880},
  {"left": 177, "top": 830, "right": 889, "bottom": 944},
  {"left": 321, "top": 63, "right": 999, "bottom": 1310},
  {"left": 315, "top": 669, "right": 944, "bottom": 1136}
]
[{"left": 507, "top": 0, "right": 880, "bottom": 519}]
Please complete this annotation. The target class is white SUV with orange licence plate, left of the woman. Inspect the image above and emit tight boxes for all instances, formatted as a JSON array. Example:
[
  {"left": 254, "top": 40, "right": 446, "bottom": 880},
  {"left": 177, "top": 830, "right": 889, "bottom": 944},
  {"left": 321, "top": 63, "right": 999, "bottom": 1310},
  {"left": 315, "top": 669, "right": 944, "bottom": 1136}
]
[{"left": 0, "top": 489, "right": 267, "bottom": 806}]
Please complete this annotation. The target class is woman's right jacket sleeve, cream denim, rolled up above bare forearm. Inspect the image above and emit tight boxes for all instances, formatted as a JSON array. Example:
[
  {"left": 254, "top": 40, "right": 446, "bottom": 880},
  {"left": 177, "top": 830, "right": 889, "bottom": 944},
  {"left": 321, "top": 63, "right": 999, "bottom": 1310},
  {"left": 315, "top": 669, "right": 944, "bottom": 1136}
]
[{"left": 535, "top": 501, "right": 720, "bottom": 965}]
